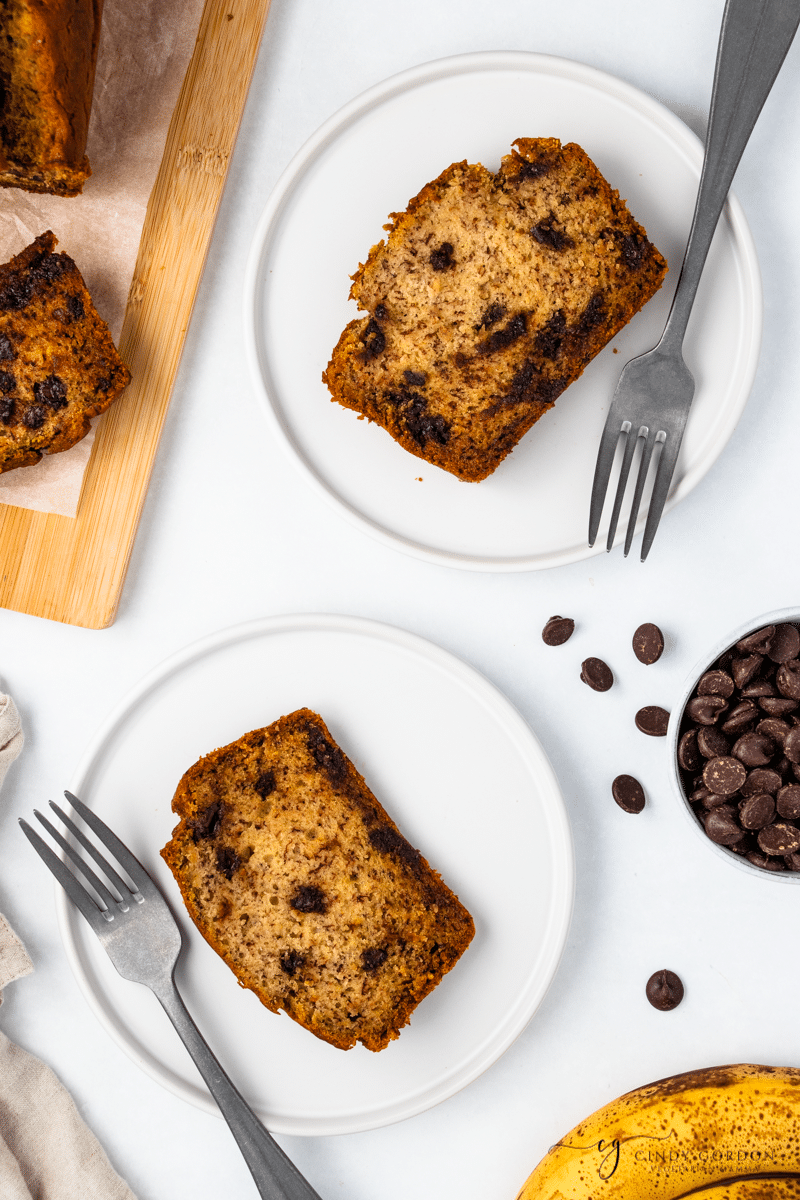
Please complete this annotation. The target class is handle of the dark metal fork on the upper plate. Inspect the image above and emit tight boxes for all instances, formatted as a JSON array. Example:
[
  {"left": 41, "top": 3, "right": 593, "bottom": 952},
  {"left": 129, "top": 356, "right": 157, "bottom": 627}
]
[{"left": 658, "top": 0, "right": 800, "bottom": 353}]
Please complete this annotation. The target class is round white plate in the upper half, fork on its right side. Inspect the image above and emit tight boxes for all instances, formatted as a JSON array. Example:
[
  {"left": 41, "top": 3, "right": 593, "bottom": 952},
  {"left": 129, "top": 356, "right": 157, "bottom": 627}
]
[{"left": 245, "top": 53, "right": 762, "bottom": 571}]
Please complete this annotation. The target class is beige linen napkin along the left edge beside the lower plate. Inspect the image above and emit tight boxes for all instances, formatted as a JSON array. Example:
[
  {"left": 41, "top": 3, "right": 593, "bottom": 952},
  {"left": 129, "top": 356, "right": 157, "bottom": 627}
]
[{"left": 0, "top": 695, "right": 136, "bottom": 1200}]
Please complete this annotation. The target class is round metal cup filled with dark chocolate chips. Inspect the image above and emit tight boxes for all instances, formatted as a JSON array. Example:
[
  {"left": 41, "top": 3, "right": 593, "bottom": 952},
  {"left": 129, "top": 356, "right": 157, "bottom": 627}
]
[{"left": 670, "top": 610, "right": 800, "bottom": 883}]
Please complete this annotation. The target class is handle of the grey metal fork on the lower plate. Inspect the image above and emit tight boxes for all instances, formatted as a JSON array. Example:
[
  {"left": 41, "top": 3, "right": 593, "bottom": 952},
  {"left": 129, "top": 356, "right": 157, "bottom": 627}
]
[{"left": 150, "top": 978, "right": 320, "bottom": 1200}]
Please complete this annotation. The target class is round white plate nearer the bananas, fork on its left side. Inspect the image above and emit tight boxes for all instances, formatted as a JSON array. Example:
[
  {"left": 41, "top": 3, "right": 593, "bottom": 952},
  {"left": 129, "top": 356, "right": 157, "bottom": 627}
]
[{"left": 56, "top": 616, "right": 573, "bottom": 1134}]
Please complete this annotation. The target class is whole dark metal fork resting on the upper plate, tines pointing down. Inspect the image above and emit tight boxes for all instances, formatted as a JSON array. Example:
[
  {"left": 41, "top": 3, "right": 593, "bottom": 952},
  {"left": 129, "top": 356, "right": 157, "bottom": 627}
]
[{"left": 589, "top": 0, "right": 800, "bottom": 562}]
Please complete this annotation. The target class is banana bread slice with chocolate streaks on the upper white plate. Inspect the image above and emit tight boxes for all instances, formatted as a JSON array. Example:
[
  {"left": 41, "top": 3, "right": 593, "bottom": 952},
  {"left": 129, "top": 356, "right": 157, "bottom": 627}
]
[{"left": 323, "top": 138, "right": 667, "bottom": 481}]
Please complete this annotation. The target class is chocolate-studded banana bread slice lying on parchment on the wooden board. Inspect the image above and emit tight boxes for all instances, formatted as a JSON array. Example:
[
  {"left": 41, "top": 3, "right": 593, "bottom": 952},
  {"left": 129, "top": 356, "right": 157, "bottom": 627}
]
[{"left": 0, "top": 230, "right": 131, "bottom": 472}]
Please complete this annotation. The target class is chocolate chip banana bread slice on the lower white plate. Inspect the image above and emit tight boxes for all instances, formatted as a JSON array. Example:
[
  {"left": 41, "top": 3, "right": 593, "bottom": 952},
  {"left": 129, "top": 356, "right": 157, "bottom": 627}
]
[{"left": 162, "top": 708, "right": 475, "bottom": 1050}]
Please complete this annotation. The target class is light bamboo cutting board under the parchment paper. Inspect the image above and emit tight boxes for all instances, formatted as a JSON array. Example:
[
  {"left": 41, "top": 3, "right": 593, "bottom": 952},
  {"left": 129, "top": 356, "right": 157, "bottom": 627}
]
[{"left": 0, "top": 0, "right": 270, "bottom": 629}]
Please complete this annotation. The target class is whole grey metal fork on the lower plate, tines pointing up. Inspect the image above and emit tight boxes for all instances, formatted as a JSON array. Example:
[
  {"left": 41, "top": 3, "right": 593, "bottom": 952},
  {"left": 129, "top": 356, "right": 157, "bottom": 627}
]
[{"left": 19, "top": 792, "right": 320, "bottom": 1200}]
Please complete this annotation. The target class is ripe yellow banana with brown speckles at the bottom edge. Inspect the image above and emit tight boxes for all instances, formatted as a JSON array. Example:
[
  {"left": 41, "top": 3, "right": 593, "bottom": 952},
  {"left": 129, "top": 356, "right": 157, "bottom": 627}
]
[{"left": 517, "top": 1063, "right": 800, "bottom": 1200}]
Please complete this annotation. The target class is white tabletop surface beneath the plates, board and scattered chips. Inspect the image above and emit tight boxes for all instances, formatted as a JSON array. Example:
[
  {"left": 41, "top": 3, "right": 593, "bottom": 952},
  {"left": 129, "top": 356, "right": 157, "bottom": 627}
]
[{"left": 0, "top": 0, "right": 800, "bottom": 1200}]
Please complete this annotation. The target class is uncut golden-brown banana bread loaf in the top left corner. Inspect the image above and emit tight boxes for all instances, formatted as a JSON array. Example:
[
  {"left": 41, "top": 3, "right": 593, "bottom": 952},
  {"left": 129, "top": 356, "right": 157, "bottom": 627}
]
[{"left": 0, "top": 0, "right": 103, "bottom": 196}]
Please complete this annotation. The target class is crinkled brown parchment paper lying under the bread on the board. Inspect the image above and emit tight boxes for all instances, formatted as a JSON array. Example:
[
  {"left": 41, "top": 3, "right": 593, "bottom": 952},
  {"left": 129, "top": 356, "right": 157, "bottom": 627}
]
[{"left": 0, "top": 0, "right": 203, "bottom": 517}]
